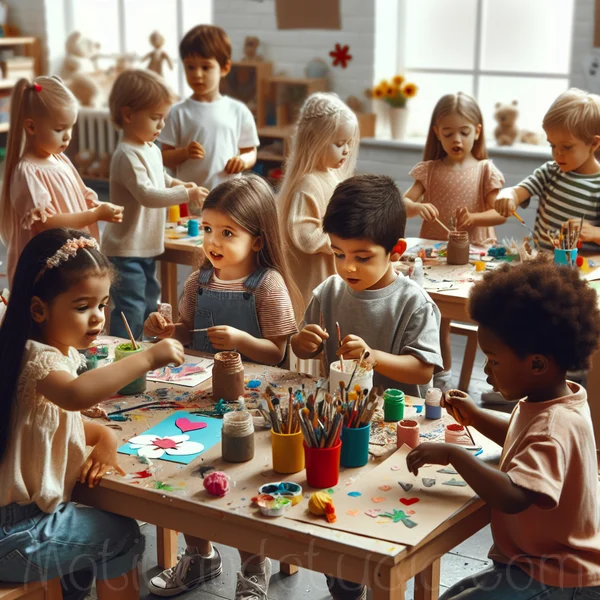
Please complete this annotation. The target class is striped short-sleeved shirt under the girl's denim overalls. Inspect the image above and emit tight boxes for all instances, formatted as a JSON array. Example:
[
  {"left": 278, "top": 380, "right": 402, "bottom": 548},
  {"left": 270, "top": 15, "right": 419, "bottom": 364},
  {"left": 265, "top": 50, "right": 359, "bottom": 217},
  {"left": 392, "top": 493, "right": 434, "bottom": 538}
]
[{"left": 179, "top": 269, "right": 298, "bottom": 339}]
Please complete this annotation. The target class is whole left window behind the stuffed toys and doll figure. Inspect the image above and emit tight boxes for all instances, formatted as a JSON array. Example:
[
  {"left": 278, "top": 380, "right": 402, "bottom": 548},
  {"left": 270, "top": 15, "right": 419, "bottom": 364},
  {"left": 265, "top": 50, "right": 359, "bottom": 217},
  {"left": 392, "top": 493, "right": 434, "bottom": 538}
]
[{"left": 65, "top": 0, "right": 212, "bottom": 95}]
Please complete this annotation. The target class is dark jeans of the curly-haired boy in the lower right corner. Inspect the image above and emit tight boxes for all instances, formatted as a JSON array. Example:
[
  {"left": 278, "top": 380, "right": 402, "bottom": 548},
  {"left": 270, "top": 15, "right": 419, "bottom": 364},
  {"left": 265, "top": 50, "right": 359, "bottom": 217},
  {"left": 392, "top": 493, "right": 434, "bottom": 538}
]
[{"left": 439, "top": 562, "right": 600, "bottom": 600}]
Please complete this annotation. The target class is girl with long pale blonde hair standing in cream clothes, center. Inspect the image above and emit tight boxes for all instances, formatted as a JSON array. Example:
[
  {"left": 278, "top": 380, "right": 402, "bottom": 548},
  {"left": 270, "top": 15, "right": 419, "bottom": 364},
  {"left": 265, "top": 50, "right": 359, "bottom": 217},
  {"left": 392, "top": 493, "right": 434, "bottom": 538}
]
[{"left": 278, "top": 92, "right": 360, "bottom": 320}]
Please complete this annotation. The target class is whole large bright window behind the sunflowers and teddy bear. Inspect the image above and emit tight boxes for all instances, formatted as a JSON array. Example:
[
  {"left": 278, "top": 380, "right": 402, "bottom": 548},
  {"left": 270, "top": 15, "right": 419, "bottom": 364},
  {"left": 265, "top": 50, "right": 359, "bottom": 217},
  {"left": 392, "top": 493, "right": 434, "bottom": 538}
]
[{"left": 384, "top": 0, "right": 574, "bottom": 139}]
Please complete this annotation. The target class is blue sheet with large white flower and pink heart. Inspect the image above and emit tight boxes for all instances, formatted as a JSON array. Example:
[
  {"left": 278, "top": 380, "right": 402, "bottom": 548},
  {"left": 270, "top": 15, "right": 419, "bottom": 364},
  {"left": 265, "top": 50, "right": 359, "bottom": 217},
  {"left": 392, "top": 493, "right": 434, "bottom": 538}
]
[{"left": 119, "top": 411, "right": 223, "bottom": 465}]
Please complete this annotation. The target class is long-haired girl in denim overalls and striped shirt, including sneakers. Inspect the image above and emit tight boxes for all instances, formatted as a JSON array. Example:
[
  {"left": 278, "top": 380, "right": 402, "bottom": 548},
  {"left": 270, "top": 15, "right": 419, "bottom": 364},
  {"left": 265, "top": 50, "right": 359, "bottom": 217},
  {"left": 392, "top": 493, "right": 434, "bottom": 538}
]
[{"left": 144, "top": 175, "right": 299, "bottom": 598}]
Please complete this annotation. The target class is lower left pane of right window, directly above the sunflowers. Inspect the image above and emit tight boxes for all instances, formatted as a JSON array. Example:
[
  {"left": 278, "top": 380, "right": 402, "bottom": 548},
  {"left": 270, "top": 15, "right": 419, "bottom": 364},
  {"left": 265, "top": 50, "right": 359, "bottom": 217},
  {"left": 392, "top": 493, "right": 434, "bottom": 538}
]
[{"left": 406, "top": 73, "right": 473, "bottom": 137}]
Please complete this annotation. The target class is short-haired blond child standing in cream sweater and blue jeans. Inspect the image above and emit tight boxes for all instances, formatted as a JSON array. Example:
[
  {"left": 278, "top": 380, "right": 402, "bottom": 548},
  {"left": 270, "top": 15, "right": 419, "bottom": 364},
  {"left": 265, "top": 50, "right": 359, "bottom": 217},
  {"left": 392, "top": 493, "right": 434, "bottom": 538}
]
[{"left": 102, "top": 69, "right": 207, "bottom": 337}]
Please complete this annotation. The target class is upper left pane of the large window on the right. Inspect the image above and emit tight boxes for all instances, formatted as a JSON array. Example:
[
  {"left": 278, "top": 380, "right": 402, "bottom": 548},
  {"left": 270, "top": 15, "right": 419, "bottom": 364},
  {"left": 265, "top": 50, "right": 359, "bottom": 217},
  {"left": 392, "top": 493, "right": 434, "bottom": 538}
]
[{"left": 403, "top": 0, "right": 477, "bottom": 69}]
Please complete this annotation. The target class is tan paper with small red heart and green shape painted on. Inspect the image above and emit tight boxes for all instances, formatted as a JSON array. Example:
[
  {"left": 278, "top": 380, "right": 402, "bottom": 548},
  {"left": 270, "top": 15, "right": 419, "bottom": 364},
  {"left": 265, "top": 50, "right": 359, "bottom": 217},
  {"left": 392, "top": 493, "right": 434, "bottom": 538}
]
[{"left": 285, "top": 445, "right": 475, "bottom": 546}]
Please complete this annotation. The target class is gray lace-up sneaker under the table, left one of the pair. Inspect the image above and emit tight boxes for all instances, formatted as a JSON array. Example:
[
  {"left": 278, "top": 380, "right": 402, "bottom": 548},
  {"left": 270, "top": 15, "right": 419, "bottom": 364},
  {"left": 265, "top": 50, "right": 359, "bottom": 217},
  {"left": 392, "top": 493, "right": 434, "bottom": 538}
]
[{"left": 148, "top": 546, "right": 223, "bottom": 598}]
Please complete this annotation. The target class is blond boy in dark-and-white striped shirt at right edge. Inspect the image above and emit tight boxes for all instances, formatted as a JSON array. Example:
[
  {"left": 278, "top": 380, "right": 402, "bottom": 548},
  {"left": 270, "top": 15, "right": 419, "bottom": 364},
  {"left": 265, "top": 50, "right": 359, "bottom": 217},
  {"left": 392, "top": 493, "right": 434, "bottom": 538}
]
[{"left": 495, "top": 88, "right": 600, "bottom": 250}]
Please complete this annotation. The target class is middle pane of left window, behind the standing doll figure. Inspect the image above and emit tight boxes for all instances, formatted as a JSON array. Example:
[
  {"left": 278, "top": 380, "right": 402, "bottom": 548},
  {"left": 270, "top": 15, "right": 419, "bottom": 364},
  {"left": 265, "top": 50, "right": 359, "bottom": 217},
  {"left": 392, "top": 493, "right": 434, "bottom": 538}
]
[{"left": 125, "top": 0, "right": 179, "bottom": 91}]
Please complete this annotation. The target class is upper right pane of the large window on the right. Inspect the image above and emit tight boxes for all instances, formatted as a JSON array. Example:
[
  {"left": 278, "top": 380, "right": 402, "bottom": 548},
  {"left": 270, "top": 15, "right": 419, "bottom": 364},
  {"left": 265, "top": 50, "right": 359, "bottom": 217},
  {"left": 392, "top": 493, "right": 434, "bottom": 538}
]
[{"left": 481, "top": 0, "right": 574, "bottom": 75}]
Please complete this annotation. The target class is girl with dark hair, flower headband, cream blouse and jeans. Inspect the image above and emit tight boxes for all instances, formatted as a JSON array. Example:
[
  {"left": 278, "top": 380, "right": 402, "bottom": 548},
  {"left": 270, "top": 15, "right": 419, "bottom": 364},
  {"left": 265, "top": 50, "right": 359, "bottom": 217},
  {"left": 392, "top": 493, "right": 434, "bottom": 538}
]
[{"left": 0, "top": 228, "right": 184, "bottom": 600}]
